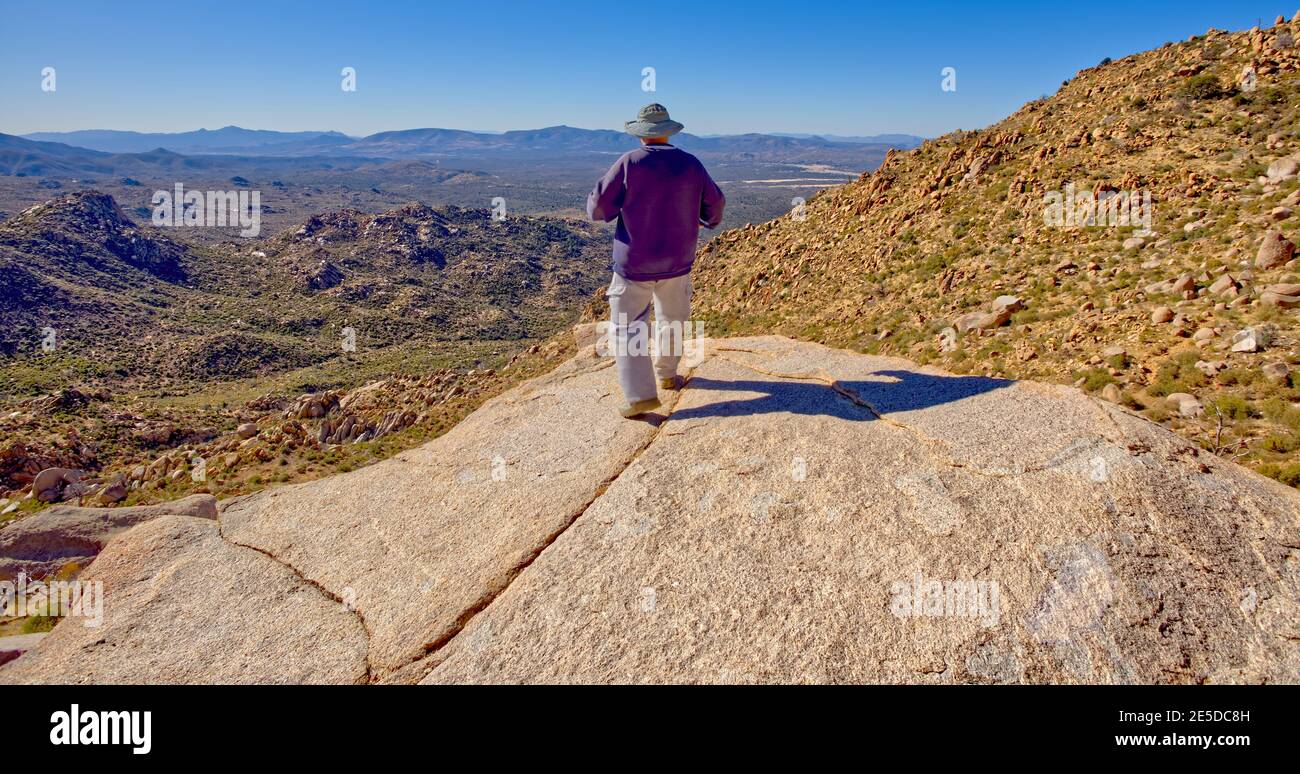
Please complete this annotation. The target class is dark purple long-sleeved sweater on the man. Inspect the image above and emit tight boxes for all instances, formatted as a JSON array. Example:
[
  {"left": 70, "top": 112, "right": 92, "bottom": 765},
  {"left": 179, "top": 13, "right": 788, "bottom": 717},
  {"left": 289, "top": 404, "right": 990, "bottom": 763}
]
[{"left": 586, "top": 146, "right": 727, "bottom": 281}]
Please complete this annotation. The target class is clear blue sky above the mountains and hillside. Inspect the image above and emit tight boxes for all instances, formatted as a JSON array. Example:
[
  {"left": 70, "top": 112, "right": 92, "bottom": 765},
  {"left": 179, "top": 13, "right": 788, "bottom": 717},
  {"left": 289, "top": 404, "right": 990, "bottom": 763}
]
[{"left": 0, "top": 0, "right": 1300, "bottom": 137}]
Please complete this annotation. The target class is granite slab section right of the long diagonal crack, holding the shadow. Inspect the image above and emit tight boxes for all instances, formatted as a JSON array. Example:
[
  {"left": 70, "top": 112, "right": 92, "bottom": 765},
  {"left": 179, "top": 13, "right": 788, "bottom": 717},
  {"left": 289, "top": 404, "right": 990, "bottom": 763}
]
[{"left": 423, "top": 340, "right": 1300, "bottom": 684}]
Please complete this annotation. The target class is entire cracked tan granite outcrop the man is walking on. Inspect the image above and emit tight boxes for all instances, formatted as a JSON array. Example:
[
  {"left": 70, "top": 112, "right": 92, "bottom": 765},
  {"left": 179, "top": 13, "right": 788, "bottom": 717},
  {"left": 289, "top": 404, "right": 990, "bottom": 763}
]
[{"left": 0, "top": 337, "right": 1300, "bottom": 683}]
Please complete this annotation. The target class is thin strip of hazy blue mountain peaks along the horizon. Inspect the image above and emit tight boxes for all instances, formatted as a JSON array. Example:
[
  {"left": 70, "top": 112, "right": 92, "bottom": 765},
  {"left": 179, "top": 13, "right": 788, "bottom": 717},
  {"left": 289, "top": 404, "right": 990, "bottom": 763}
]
[{"left": 12, "top": 126, "right": 923, "bottom": 157}]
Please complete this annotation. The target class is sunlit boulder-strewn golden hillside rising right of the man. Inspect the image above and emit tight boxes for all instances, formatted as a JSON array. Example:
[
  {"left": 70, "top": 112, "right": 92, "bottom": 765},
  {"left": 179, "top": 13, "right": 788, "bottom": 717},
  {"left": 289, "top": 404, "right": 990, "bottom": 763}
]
[{"left": 696, "top": 14, "right": 1300, "bottom": 485}]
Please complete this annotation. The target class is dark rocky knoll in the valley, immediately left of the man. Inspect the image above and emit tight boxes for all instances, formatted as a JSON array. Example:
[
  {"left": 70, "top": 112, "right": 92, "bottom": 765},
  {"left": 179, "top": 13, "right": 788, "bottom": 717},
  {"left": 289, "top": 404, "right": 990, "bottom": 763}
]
[{"left": 259, "top": 204, "right": 595, "bottom": 343}]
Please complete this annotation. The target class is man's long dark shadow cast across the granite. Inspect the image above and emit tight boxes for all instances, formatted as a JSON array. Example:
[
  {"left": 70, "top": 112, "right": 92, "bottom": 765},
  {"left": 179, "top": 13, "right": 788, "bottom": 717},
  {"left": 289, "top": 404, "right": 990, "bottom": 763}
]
[{"left": 668, "top": 371, "right": 1015, "bottom": 421}]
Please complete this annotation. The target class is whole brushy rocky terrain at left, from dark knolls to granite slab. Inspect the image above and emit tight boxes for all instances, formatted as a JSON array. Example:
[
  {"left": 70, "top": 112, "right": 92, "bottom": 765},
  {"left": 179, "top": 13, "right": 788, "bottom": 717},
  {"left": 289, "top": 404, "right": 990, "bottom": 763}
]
[{"left": 0, "top": 193, "right": 608, "bottom": 509}]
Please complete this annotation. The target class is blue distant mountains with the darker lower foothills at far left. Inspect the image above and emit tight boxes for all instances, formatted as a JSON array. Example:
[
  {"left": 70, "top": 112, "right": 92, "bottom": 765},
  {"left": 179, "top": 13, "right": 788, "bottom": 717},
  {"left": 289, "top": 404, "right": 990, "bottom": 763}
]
[{"left": 0, "top": 126, "right": 919, "bottom": 180}]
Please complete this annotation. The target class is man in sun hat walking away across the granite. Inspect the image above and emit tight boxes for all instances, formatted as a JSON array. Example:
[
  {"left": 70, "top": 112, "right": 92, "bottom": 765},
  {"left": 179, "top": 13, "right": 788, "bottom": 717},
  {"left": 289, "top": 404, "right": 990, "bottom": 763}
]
[{"left": 586, "top": 104, "right": 727, "bottom": 419}]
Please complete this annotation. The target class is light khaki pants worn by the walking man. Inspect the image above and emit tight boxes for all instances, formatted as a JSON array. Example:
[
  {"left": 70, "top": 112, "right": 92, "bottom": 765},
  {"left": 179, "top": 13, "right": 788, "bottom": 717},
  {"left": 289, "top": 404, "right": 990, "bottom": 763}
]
[{"left": 606, "top": 274, "right": 692, "bottom": 403}]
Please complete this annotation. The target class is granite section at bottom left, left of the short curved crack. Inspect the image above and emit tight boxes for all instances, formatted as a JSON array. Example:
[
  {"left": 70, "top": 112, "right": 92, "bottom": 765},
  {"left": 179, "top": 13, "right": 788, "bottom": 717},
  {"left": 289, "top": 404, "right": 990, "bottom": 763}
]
[{"left": 0, "top": 515, "right": 368, "bottom": 684}]
